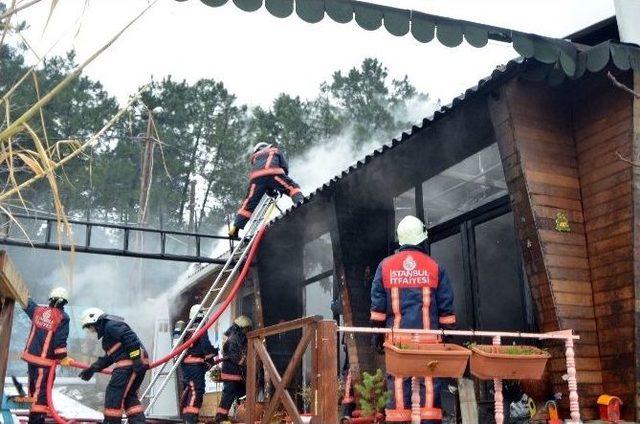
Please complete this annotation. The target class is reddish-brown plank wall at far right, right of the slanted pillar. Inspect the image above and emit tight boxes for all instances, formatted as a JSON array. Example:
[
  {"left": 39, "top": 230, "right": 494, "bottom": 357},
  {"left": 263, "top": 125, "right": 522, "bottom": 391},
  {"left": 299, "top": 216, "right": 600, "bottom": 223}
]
[{"left": 571, "top": 74, "right": 636, "bottom": 420}]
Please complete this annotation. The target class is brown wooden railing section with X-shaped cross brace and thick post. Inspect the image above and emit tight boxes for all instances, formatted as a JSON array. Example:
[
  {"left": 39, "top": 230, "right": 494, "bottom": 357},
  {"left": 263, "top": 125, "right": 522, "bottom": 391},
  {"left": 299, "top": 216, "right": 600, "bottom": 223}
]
[{"left": 247, "top": 316, "right": 338, "bottom": 424}]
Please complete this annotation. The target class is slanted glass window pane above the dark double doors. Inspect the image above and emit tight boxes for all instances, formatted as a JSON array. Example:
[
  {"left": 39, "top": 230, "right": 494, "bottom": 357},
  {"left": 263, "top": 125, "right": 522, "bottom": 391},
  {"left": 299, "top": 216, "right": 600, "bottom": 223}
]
[{"left": 422, "top": 144, "right": 507, "bottom": 227}]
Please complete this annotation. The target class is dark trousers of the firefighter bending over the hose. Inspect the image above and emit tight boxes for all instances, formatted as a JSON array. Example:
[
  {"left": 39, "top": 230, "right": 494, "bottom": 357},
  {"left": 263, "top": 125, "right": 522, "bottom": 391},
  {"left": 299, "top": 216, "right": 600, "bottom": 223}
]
[{"left": 104, "top": 366, "right": 146, "bottom": 423}]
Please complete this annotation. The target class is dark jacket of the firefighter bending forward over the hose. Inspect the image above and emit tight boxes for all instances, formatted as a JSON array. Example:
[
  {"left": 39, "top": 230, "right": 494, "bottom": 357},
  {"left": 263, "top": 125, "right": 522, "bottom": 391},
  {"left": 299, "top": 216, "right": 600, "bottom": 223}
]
[{"left": 91, "top": 315, "right": 149, "bottom": 371}]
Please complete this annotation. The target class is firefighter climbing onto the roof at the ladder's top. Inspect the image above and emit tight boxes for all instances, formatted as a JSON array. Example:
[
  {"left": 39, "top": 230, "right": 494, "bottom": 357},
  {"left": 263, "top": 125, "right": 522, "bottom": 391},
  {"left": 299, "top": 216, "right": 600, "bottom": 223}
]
[{"left": 229, "top": 142, "right": 304, "bottom": 237}]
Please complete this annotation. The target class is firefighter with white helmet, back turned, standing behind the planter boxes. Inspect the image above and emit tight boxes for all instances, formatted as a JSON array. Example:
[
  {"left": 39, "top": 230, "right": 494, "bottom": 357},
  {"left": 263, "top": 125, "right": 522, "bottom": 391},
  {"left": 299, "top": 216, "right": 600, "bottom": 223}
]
[{"left": 371, "top": 216, "right": 456, "bottom": 424}]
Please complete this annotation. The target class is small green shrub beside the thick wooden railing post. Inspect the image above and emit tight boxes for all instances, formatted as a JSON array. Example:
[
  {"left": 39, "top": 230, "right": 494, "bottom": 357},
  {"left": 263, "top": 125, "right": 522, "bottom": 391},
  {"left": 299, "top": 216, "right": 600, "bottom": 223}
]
[{"left": 351, "top": 369, "right": 391, "bottom": 424}]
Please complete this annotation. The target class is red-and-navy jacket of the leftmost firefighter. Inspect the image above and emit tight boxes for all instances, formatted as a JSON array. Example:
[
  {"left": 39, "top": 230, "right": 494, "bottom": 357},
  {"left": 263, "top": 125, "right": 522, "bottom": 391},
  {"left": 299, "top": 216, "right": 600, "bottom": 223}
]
[{"left": 22, "top": 298, "right": 69, "bottom": 367}]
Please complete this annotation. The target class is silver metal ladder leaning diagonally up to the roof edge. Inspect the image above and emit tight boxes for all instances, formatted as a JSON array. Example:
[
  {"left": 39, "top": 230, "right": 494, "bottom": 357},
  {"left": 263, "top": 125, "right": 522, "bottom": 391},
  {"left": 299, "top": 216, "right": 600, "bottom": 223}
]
[{"left": 142, "top": 194, "right": 276, "bottom": 414}]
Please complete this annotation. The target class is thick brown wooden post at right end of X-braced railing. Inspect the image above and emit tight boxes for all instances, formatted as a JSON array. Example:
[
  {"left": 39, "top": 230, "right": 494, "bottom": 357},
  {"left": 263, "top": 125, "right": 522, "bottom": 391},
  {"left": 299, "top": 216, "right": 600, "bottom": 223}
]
[{"left": 316, "top": 321, "right": 338, "bottom": 423}]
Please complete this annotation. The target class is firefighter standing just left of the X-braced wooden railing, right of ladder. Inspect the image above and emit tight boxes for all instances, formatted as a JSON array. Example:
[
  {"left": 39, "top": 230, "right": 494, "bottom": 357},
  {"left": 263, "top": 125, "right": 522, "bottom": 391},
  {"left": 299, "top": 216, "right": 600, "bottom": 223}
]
[{"left": 213, "top": 315, "right": 252, "bottom": 423}]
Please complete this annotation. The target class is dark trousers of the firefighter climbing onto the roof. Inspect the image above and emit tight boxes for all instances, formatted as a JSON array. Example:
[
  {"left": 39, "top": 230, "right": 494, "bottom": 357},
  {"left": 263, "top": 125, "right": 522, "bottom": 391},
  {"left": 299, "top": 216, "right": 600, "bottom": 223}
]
[{"left": 233, "top": 175, "right": 304, "bottom": 229}]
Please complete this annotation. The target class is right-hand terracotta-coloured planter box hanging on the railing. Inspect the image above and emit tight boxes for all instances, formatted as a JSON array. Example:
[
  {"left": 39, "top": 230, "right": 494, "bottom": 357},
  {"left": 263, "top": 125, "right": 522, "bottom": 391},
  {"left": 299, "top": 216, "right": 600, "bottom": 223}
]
[{"left": 471, "top": 345, "right": 551, "bottom": 380}]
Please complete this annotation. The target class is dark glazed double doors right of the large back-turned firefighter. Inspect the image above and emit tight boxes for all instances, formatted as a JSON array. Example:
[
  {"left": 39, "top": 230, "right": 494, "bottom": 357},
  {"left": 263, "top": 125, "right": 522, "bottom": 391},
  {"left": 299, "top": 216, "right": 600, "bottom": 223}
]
[{"left": 430, "top": 198, "right": 533, "bottom": 331}]
